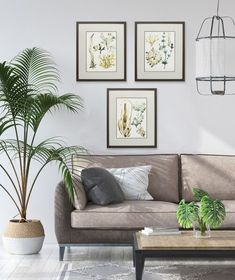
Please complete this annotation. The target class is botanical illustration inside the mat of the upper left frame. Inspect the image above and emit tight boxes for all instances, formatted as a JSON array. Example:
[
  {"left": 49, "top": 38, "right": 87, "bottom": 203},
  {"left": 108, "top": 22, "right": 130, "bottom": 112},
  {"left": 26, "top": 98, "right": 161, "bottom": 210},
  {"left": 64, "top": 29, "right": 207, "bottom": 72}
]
[{"left": 86, "top": 31, "right": 117, "bottom": 72}]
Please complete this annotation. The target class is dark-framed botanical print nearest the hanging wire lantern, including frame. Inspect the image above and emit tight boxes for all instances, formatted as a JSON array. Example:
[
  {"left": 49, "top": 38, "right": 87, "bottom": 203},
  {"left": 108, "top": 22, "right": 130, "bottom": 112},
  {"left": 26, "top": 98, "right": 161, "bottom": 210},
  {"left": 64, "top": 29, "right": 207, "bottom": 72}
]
[{"left": 135, "top": 22, "right": 185, "bottom": 81}]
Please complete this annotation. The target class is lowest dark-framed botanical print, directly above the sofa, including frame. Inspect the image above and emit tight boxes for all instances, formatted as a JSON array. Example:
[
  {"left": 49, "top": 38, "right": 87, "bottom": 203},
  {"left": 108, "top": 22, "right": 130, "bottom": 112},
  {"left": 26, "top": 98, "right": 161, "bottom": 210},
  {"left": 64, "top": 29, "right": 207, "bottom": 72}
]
[{"left": 107, "top": 88, "right": 157, "bottom": 148}]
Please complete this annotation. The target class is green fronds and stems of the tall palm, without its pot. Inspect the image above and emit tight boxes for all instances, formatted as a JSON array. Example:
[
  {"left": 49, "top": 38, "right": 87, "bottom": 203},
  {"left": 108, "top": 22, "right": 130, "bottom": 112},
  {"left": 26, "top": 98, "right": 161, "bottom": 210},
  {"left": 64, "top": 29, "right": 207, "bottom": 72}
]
[{"left": 0, "top": 48, "right": 86, "bottom": 220}]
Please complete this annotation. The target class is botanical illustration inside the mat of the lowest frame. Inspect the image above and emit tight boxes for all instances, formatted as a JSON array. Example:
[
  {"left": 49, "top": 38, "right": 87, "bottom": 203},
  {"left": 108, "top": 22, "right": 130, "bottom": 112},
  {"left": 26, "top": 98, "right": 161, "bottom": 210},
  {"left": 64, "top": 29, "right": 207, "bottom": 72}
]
[{"left": 116, "top": 98, "right": 147, "bottom": 138}]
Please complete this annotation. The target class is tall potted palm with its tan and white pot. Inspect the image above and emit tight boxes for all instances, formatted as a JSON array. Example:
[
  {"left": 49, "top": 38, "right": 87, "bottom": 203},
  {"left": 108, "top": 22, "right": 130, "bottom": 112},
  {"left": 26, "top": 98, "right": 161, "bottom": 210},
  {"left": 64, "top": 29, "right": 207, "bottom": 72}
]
[{"left": 0, "top": 48, "right": 84, "bottom": 254}]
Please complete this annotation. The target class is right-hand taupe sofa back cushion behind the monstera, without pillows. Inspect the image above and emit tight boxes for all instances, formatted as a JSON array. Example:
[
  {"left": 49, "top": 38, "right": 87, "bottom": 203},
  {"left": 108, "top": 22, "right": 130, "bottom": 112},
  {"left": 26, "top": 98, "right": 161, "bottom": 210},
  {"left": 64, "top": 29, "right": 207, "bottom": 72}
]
[{"left": 181, "top": 155, "right": 235, "bottom": 201}]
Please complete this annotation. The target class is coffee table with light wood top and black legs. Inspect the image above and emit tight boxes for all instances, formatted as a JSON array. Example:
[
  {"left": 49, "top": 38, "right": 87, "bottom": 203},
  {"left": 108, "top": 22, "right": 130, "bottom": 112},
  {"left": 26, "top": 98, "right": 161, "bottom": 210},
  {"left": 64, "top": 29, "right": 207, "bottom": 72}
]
[{"left": 133, "top": 230, "right": 235, "bottom": 280}]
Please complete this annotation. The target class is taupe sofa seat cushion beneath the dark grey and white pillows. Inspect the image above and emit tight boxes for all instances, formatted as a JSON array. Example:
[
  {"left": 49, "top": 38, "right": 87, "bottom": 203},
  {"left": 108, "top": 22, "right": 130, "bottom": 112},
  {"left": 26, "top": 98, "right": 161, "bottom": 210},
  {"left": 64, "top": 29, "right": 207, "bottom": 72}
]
[{"left": 71, "top": 200, "right": 178, "bottom": 229}]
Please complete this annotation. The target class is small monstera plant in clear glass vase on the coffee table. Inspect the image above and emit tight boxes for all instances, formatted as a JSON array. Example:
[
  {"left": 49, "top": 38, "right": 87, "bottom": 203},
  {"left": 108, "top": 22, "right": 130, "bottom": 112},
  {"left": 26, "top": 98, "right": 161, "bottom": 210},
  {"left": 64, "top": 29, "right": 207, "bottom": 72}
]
[{"left": 176, "top": 188, "right": 226, "bottom": 238}]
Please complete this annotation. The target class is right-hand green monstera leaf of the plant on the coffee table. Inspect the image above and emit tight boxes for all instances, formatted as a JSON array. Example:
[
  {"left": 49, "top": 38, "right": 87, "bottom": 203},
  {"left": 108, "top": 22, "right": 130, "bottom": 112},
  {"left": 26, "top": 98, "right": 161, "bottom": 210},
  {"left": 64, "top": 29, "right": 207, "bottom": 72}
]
[{"left": 200, "top": 196, "right": 226, "bottom": 228}]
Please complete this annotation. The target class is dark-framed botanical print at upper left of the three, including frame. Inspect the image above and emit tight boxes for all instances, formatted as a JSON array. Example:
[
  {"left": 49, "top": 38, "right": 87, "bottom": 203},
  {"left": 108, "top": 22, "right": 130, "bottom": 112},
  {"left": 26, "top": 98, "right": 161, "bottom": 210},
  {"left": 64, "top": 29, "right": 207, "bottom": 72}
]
[{"left": 77, "top": 22, "right": 126, "bottom": 81}]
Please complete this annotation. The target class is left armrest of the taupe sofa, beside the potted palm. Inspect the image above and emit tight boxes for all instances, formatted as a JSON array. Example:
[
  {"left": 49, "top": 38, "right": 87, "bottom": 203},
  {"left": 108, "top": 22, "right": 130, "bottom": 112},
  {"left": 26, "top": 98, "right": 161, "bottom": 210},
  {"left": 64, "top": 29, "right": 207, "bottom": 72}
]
[{"left": 54, "top": 182, "right": 74, "bottom": 243}]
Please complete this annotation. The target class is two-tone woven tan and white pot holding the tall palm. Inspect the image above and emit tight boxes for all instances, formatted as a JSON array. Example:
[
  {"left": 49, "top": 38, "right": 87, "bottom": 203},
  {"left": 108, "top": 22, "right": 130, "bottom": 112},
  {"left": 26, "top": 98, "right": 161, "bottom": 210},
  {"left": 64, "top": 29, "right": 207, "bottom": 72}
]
[{"left": 3, "top": 220, "right": 45, "bottom": 255}]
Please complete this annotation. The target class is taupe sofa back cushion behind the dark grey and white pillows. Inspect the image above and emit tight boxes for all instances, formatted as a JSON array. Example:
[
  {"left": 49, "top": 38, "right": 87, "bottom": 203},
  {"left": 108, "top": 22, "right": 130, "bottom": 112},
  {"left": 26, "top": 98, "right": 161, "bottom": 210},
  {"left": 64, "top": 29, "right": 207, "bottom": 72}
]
[{"left": 73, "top": 155, "right": 179, "bottom": 202}]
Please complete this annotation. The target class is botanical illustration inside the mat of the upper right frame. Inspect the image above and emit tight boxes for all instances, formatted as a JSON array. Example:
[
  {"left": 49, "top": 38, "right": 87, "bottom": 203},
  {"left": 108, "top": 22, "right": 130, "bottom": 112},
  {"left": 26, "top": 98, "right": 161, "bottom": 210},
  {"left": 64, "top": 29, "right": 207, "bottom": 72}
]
[{"left": 145, "top": 31, "right": 175, "bottom": 72}]
